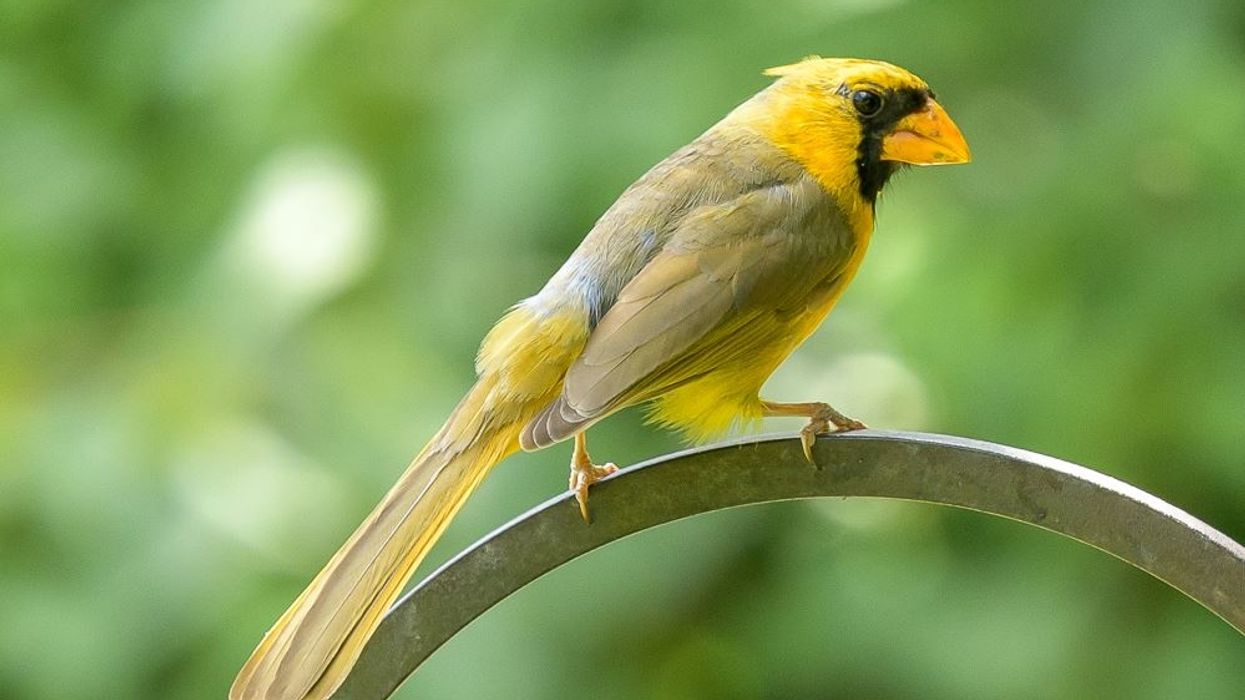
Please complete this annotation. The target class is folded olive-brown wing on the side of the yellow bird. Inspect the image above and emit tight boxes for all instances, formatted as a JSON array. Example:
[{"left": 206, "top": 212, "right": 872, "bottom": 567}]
[{"left": 523, "top": 178, "right": 848, "bottom": 448}]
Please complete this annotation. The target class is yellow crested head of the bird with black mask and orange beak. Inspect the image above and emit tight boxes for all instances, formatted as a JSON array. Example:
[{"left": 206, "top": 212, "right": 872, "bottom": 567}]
[{"left": 741, "top": 57, "right": 970, "bottom": 208}]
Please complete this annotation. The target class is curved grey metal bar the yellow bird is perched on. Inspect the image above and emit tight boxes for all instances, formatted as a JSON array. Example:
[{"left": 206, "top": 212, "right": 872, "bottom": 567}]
[{"left": 334, "top": 431, "right": 1245, "bottom": 700}]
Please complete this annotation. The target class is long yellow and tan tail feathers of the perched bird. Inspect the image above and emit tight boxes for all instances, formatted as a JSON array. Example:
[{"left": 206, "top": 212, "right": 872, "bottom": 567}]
[{"left": 229, "top": 379, "right": 527, "bottom": 700}]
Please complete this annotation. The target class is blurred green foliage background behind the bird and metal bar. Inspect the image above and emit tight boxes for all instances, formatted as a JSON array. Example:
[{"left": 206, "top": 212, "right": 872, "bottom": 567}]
[{"left": 0, "top": 0, "right": 1245, "bottom": 699}]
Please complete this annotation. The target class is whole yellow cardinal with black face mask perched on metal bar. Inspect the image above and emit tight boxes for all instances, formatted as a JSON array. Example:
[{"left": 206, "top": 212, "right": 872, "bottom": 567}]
[{"left": 229, "top": 57, "right": 969, "bottom": 700}]
